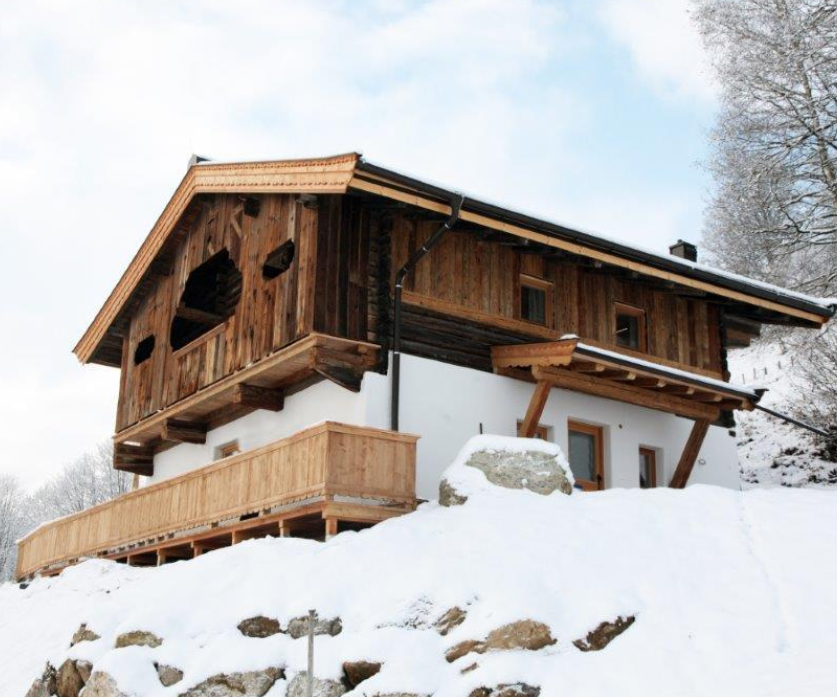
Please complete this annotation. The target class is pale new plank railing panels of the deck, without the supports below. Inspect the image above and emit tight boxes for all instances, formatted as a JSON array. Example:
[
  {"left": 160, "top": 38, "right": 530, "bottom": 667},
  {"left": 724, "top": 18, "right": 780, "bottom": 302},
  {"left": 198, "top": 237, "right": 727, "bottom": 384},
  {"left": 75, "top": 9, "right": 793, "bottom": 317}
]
[{"left": 17, "top": 422, "right": 417, "bottom": 578}]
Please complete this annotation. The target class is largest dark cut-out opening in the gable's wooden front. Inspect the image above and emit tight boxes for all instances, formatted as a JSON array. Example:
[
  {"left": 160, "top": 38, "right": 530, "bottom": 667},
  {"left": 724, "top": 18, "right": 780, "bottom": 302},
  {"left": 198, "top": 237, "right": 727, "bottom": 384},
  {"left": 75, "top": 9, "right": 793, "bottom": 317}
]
[{"left": 169, "top": 249, "right": 241, "bottom": 351}]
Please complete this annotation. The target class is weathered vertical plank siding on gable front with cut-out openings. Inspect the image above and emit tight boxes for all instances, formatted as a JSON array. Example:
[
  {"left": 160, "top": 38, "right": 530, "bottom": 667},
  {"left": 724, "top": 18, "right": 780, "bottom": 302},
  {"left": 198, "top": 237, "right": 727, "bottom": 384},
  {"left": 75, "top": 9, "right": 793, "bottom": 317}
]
[{"left": 117, "top": 195, "right": 318, "bottom": 431}]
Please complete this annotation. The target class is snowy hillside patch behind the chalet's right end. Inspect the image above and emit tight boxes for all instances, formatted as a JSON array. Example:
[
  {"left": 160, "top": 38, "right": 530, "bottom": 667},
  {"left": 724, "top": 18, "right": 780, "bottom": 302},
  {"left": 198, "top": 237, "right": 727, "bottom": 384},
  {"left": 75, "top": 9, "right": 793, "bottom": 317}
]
[{"left": 729, "top": 342, "right": 837, "bottom": 489}]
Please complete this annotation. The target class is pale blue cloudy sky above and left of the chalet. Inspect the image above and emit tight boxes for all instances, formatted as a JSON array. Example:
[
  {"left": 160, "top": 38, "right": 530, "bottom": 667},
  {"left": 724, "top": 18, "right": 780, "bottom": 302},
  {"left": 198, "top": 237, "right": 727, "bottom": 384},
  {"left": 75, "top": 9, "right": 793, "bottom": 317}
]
[{"left": 0, "top": 0, "right": 717, "bottom": 489}]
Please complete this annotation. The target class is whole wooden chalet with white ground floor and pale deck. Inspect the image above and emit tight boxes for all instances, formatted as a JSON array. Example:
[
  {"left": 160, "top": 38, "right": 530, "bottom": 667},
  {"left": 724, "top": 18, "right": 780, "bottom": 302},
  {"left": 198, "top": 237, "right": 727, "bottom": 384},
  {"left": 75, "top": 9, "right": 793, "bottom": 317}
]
[{"left": 17, "top": 154, "right": 834, "bottom": 578}]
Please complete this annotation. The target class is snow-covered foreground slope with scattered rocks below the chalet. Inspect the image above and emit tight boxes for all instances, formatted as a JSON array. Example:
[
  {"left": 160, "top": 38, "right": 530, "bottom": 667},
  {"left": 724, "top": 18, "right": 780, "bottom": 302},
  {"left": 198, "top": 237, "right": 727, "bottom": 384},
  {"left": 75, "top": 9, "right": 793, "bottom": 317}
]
[{"left": 0, "top": 438, "right": 837, "bottom": 697}]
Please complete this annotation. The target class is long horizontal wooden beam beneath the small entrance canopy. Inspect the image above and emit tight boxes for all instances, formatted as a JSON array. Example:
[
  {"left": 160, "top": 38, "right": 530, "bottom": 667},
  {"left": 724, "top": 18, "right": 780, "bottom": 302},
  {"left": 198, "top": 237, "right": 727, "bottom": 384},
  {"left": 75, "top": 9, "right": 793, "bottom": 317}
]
[{"left": 532, "top": 367, "right": 720, "bottom": 421}]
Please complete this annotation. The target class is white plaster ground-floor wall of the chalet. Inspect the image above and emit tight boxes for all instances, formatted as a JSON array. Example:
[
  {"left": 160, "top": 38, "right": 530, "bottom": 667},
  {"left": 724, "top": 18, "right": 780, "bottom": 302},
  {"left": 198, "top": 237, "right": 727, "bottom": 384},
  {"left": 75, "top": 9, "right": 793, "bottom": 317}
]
[{"left": 151, "top": 356, "right": 739, "bottom": 499}]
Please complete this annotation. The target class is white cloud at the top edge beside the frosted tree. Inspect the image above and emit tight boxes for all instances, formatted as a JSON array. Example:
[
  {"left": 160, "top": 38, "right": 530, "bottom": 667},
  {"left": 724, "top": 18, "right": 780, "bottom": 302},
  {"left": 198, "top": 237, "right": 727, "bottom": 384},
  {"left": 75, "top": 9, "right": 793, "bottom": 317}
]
[{"left": 599, "top": 0, "right": 717, "bottom": 102}]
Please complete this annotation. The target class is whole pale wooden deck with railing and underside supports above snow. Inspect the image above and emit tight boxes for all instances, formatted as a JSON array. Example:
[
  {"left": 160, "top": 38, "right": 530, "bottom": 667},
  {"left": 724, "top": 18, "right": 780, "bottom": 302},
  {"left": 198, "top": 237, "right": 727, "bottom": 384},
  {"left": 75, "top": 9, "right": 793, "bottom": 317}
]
[{"left": 17, "top": 422, "right": 418, "bottom": 579}]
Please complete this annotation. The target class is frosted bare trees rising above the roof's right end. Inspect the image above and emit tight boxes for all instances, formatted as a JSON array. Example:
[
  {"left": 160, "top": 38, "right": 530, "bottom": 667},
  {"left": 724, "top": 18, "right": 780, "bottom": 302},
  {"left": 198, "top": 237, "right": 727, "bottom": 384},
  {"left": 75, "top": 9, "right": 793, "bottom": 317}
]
[{"left": 694, "top": 0, "right": 837, "bottom": 293}]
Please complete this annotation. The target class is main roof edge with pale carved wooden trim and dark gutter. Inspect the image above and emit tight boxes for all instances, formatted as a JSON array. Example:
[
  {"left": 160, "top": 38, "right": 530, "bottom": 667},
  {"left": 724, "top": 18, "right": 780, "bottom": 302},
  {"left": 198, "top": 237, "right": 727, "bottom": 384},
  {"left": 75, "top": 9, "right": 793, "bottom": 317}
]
[{"left": 73, "top": 153, "right": 835, "bottom": 363}]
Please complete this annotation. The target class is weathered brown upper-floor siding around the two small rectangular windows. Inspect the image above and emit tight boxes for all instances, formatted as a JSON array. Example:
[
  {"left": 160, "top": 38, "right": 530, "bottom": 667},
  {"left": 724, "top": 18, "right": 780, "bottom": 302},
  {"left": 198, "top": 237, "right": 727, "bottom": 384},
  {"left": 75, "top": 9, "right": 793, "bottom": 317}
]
[{"left": 391, "top": 213, "right": 722, "bottom": 374}]
